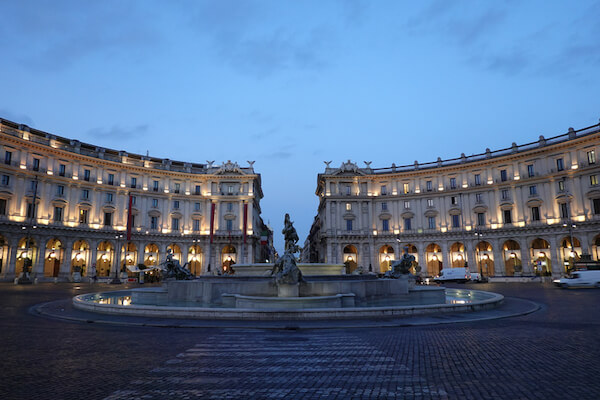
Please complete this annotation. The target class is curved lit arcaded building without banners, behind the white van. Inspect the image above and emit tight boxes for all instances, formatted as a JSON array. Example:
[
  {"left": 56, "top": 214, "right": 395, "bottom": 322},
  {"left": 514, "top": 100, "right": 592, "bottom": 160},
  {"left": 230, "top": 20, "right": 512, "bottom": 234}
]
[{"left": 303, "top": 124, "right": 600, "bottom": 276}]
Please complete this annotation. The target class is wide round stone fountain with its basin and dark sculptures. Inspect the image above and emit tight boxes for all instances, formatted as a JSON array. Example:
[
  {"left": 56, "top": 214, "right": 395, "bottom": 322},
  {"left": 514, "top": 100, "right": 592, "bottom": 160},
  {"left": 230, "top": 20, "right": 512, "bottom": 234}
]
[{"left": 73, "top": 214, "right": 503, "bottom": 320}]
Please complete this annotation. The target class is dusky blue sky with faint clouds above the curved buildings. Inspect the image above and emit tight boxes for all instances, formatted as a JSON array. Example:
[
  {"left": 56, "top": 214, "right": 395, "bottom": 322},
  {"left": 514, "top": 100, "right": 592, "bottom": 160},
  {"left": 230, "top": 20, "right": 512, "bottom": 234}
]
[{"left": 0, "top": 0, "right": 600, "bottom": 250}]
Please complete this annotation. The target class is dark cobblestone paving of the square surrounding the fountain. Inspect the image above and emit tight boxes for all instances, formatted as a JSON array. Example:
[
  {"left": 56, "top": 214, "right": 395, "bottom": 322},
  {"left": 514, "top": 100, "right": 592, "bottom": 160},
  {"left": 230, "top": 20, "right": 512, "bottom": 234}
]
[{"left": 0, "top": 283, "right": 600, "bottom": 400}]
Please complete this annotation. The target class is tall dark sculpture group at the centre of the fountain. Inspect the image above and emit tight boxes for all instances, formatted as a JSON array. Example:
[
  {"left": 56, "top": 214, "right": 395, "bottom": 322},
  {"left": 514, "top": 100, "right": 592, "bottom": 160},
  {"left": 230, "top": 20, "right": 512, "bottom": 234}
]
[{"left": 271, "top": 214, "right": 304, "bottom": 297}]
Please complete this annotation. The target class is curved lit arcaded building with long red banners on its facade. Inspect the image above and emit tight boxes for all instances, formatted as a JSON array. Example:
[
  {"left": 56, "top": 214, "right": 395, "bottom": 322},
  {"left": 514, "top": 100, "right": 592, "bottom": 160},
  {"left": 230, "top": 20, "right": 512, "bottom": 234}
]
[{"left": 0, "top": 120, "right": 269, "bottom": 281}]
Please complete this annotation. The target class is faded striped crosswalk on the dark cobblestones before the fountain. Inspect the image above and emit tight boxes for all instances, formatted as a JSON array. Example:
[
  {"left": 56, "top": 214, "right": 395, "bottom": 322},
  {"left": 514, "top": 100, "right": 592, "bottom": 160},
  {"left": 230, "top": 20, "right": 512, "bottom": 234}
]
[{"left": 105, "top": 331, "right": 447, "bottom": 400}]
